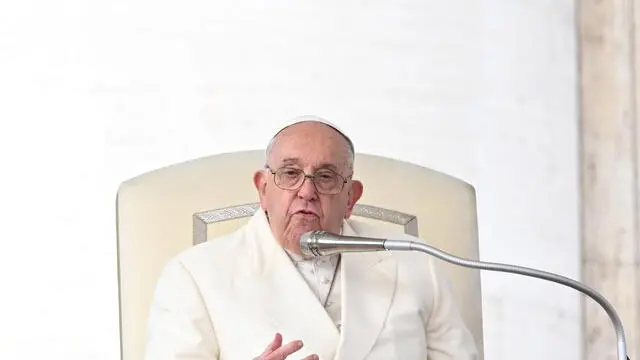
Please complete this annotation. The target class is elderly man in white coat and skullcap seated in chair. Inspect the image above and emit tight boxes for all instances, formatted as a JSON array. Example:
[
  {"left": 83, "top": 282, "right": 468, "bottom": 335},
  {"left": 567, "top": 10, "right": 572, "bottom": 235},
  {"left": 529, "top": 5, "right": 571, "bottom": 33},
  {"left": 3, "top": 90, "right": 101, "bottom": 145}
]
[{"left": 146, "top": 118, "right": 478, "bottom": 360}]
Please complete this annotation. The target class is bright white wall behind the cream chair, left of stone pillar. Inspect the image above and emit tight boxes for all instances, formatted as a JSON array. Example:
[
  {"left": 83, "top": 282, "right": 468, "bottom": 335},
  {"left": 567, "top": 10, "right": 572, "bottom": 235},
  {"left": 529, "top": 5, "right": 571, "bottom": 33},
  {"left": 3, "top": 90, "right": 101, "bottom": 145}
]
[{"left": 0, "top": 0, "right": 582, "bottom": 360}]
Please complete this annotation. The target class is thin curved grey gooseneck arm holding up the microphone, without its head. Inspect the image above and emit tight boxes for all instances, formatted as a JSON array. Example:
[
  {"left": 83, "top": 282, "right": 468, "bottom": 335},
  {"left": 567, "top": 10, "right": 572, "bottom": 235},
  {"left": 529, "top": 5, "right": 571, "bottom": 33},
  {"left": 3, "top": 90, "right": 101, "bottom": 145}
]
[{"left": 384, "top": 240, "right": 629, "bottom": 360}]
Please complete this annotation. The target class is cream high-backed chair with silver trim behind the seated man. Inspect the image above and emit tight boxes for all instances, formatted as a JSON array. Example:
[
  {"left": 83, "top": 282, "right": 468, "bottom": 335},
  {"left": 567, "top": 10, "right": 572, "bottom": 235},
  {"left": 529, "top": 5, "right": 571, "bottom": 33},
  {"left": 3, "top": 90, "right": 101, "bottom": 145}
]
[{"left": 116, "top": 151, "right": 483, "bottom": 360}]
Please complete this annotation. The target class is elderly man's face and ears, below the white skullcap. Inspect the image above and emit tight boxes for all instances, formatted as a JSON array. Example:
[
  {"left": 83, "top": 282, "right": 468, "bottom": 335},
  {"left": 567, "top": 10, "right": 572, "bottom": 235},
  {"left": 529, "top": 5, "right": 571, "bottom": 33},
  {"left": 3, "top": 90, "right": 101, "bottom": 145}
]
[{"left": 254, "top": 122, "right": 362, "bottom": 254}]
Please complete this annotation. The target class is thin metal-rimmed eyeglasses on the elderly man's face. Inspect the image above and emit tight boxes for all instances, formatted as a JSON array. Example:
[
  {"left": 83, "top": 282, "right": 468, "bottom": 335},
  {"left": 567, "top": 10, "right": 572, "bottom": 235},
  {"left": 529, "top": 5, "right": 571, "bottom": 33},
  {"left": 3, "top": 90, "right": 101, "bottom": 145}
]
[{"left": 265, "top": 165, "right": 350, "bottom": 195}]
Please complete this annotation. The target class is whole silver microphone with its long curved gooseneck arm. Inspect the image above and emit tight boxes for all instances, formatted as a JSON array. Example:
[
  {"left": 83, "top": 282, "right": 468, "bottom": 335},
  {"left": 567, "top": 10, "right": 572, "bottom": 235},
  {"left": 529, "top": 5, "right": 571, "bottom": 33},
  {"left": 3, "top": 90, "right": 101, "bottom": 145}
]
[{"left": 300, "top": 230, "right": 629, "bottom": 360}]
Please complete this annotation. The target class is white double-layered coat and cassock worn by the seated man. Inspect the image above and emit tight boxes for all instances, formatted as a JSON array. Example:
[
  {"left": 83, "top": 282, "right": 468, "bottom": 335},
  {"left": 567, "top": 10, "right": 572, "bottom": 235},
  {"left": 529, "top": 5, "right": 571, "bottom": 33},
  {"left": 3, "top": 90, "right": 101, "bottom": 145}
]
[{"left": 145, "top": 210, "right": 478, "bottom": 360}]
